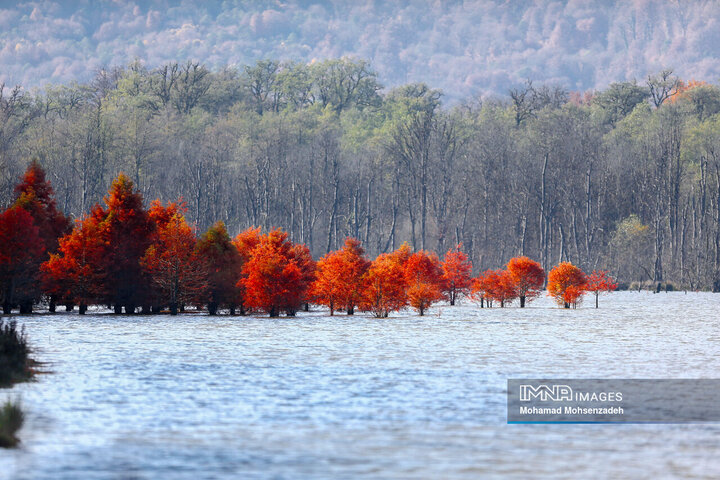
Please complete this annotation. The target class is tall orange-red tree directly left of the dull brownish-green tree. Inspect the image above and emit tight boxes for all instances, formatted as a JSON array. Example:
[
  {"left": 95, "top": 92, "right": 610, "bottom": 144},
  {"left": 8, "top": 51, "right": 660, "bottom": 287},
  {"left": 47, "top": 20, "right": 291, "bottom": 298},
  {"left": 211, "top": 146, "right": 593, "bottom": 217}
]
[{"left": 140, "top": 213, "right": 208, "bottom": 315}]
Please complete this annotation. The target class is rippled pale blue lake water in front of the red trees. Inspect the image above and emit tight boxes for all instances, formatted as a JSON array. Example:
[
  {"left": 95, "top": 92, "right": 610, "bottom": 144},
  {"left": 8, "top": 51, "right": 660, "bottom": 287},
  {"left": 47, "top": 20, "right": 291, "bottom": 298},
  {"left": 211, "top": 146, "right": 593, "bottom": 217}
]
[{"left": 0, "top": 292, "right": 720, "bottom": 480}]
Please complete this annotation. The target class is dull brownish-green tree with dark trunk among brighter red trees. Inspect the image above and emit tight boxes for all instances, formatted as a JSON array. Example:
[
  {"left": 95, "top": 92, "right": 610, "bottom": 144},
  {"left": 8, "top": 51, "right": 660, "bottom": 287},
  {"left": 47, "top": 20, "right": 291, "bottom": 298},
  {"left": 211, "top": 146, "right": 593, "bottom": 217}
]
[{"left": 196, "top": 222, "right": 245, "bottom": 315}]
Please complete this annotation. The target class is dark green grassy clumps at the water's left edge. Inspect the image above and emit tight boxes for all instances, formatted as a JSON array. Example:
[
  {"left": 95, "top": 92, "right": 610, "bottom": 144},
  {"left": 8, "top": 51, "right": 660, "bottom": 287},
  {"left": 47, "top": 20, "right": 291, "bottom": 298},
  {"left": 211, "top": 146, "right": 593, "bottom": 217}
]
[{"left": 0, "top": 318, "right": 36, "bottom": 448}]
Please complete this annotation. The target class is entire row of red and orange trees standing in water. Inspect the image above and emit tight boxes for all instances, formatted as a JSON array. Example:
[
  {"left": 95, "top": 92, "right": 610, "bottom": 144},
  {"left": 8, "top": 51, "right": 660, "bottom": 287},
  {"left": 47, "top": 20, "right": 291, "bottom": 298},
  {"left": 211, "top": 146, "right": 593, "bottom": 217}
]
[{"left": 0, "top": 163, "right": 615, "bottom": 317}]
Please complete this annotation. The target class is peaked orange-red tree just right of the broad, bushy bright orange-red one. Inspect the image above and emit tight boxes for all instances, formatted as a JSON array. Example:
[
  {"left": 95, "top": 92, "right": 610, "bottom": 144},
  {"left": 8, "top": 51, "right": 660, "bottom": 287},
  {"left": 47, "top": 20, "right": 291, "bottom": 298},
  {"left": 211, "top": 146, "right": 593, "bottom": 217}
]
[{"left": 310, "top": 237, "right": 370, "bottom": 315}]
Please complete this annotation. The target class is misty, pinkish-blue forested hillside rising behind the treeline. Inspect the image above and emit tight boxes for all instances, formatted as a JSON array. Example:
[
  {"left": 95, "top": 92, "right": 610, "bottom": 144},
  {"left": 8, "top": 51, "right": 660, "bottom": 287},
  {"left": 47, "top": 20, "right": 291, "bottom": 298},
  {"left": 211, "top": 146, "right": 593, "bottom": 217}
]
[{"left": 0, "top": 0, "right": 720, "bottom": 100}]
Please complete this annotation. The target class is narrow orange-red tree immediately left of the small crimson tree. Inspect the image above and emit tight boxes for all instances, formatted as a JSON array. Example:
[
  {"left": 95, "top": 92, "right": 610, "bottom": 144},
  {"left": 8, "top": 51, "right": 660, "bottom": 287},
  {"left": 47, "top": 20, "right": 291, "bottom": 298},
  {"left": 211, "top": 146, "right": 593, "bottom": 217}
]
[{"left": 405, "top": 250, "right": 443, "bottom": 316}]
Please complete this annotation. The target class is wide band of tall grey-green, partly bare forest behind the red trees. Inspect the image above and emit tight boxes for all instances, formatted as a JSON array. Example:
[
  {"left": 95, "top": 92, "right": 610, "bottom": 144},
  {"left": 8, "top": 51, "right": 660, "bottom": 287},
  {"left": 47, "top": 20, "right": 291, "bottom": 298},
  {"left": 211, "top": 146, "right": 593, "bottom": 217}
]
[{"left": 0, "top": 59, "right": 720, "bottom": 290}]
